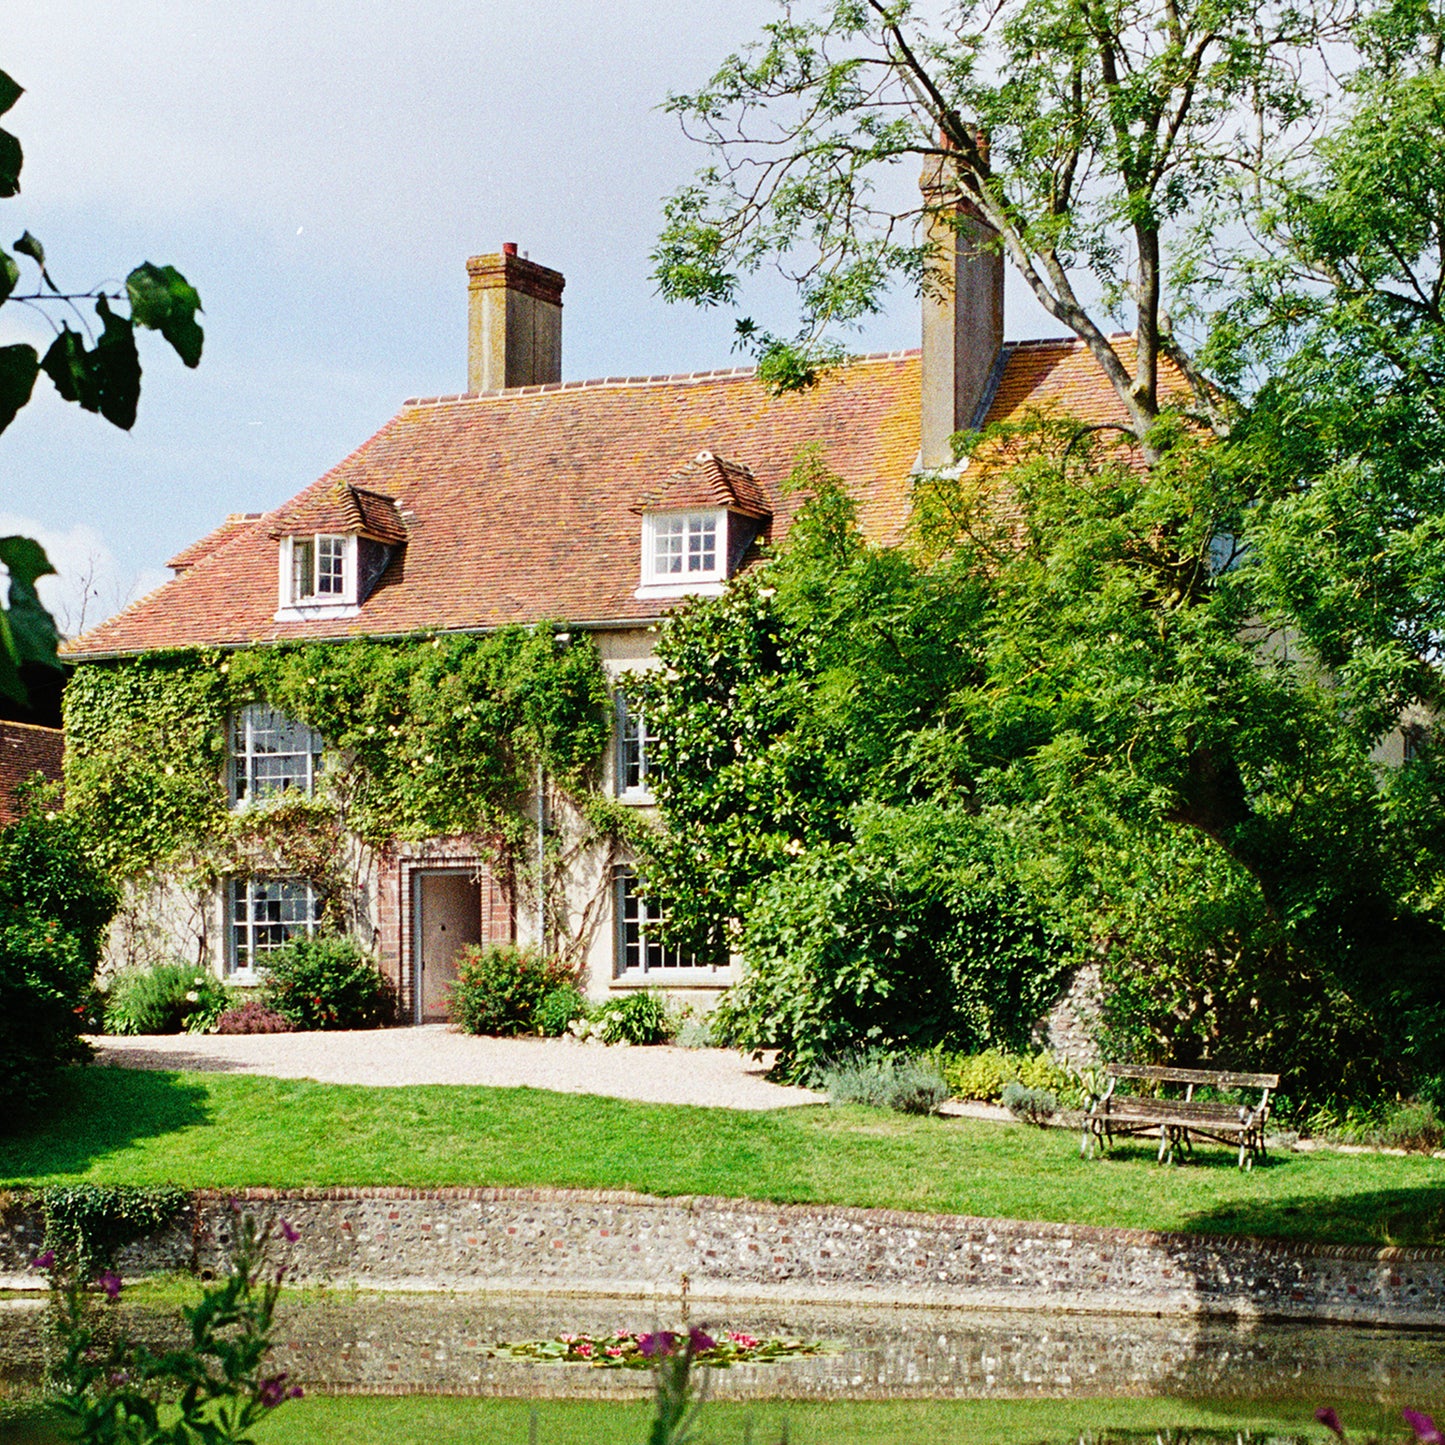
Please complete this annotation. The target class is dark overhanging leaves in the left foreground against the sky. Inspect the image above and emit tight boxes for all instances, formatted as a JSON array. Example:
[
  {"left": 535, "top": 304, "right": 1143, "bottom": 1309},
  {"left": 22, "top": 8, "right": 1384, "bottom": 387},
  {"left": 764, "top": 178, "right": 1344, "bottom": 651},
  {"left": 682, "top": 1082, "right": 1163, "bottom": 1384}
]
[{"left": 0, "top": 71, "right": 204, "bottom": 704}]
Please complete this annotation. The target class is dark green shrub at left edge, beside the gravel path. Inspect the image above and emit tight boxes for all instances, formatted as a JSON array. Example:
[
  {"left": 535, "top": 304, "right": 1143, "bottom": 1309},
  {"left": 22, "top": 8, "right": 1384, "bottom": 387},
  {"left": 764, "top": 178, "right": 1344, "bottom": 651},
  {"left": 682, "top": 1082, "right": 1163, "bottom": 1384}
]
[{"left": 0, "top": 790, "right": 116, "bottom": 1131}]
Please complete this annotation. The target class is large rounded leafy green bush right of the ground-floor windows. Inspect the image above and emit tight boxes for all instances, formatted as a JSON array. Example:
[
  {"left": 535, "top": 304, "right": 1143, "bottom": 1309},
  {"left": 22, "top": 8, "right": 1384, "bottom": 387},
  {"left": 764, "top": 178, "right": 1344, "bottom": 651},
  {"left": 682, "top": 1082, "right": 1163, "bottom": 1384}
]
[{"left": 714, "top": 805, "right": 1068, "bottom": 1078}]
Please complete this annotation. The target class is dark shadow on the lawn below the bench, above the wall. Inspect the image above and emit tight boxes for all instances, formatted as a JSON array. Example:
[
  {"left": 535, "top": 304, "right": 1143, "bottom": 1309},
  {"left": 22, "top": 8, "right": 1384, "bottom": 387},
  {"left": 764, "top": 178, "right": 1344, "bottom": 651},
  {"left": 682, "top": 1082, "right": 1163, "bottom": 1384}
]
[{"left": 1185, "top": 1173, "right": 1445, "bottom": 1248}]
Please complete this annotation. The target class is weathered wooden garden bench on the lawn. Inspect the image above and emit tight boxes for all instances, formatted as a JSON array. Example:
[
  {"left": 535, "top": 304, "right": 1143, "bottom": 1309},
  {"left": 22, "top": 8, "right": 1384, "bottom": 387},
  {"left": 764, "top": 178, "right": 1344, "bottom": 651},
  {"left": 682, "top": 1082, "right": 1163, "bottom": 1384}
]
[{"left": 1079, "top": 1064, "right": 1279, "bottom": 1169}]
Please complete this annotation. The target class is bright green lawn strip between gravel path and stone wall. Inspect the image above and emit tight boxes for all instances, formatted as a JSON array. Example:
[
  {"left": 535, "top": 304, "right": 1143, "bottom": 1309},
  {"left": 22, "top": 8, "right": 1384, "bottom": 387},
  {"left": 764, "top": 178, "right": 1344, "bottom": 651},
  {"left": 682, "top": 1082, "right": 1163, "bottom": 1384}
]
[{"left": 0, "top": 1068, "right": 1445, "bottom": 1244}]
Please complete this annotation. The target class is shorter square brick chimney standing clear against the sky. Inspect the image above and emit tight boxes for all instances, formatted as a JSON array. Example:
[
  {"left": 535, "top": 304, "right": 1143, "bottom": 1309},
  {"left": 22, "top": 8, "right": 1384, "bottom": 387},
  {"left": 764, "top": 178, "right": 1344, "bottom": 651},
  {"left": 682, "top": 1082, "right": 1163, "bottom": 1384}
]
[{"left": 467, "top": 241, "right": 566, "bottom": 392}]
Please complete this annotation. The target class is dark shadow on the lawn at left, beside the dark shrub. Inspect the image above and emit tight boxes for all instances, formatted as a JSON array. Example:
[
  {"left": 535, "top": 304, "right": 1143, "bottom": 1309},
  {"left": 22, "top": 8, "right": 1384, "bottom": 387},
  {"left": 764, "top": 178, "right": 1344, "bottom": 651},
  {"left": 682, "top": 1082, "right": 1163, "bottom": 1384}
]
[{"left": 0, "top": 1068, "right": 210, "bottom": 1185}]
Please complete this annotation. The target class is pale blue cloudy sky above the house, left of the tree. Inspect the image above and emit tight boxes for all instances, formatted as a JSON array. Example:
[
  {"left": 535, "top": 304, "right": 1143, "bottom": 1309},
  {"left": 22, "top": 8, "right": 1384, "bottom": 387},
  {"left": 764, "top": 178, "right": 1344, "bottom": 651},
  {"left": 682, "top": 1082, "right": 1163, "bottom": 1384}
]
[{"left": 0, "top": 0, "right": 1063, "bottom": 627}]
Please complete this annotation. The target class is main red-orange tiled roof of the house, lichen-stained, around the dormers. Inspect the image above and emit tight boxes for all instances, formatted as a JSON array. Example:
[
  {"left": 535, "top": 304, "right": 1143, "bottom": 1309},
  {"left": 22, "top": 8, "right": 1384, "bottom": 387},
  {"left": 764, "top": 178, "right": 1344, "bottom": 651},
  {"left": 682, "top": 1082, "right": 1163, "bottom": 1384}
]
[{"left": 66, "top": 341, "right": 1161, "bottom": 657}]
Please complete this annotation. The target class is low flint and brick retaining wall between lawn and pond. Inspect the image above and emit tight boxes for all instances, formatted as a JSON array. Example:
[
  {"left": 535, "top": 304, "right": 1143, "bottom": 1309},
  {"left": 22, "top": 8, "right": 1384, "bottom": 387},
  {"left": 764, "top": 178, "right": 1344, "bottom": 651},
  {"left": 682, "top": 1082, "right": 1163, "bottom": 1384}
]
[{"left": 0, "top": 1189, "right": 1445, "bottom": 1327}]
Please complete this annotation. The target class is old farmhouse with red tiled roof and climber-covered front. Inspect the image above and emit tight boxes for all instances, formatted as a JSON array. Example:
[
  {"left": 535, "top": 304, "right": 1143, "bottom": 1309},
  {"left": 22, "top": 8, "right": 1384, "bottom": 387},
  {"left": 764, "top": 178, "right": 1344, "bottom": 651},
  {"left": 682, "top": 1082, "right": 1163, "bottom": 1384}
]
[{"left": 68, "top": 219, "right": 1150, "bottom": 1022}]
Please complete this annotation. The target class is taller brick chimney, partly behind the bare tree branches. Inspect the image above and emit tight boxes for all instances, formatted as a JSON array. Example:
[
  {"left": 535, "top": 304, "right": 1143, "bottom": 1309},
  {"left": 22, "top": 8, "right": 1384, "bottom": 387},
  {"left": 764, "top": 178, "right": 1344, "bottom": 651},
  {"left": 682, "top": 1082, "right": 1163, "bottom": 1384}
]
[{"left": 919, "top": 159, "right": 1003, "bottom": 467}]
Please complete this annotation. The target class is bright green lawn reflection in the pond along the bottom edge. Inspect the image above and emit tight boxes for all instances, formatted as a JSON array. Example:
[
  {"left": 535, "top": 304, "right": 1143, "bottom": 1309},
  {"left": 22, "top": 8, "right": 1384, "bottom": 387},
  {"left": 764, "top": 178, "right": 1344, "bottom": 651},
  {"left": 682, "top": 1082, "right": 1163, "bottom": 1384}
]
[{"left": 0, "top": 1396, "right": 1398, "bottom": 1445}]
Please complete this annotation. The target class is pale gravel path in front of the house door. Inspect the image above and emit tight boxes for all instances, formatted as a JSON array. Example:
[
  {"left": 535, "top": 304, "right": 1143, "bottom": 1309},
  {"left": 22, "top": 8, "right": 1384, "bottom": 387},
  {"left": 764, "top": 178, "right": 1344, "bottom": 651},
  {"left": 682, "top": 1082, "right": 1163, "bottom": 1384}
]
[{"left": 91, "top": 1023, "right": 824, "bottom": 1110}]
